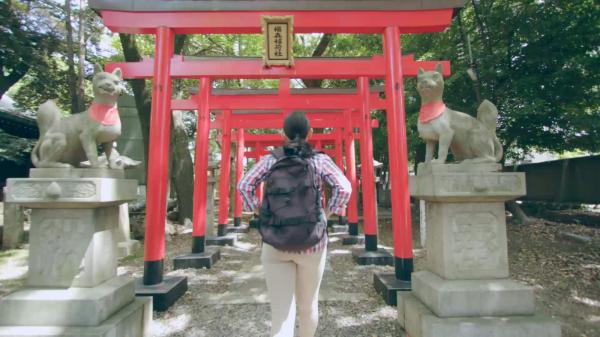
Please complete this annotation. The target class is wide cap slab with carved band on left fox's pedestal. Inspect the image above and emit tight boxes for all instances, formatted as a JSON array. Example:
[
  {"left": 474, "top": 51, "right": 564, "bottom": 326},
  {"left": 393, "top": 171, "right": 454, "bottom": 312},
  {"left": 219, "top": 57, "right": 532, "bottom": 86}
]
[{"left": 6, "top": 178, "right": 137, "bottom": 208}]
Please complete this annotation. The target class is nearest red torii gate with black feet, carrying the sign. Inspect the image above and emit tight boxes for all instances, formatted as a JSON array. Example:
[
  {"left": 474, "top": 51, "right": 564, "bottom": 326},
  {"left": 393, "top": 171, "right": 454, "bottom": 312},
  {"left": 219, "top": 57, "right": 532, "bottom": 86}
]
[{"left": 89, "top": 0, "right": 464, "bottom": 310}]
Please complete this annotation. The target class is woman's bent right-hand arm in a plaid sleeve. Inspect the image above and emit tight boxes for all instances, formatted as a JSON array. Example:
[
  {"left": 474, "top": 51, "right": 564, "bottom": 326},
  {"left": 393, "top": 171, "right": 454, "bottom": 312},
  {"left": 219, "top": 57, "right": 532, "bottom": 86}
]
[{"left": 318, "top": 155, "right": 352, "bottom": 217}]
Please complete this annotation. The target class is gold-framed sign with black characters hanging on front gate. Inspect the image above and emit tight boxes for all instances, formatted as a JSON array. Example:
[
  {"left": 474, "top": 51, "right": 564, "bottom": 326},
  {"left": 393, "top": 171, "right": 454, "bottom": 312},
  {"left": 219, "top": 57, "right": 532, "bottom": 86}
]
[{"left": 262, "top": 16, "right": 294, "bottom": 67}]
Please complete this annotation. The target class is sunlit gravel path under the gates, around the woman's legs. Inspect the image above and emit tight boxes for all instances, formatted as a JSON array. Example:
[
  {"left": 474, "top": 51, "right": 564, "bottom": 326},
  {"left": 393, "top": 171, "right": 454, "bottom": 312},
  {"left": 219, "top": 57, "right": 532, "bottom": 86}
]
[{"left": 120, "top": 226, "right": 398, "bottom": 337}]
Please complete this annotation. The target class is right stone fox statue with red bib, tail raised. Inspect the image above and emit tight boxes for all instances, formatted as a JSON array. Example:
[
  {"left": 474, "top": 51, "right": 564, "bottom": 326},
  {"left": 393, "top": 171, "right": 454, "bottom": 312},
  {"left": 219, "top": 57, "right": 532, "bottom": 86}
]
[{"left": 417, "top": 64, "right": 503, "bottom": 164}]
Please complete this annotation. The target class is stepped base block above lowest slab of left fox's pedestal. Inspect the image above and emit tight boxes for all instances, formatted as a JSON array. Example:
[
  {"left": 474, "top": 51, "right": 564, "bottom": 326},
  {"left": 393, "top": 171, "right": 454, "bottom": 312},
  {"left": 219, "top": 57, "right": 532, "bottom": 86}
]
[{"left": 0, "top": 277, "right": 135, "bottom": 326}]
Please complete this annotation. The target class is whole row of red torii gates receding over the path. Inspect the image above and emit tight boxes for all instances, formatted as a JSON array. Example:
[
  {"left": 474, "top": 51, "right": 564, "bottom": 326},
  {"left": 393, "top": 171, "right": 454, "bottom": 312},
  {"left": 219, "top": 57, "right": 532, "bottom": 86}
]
[{"left": 90, "top": 0, "right": 462, "bottom": 310}]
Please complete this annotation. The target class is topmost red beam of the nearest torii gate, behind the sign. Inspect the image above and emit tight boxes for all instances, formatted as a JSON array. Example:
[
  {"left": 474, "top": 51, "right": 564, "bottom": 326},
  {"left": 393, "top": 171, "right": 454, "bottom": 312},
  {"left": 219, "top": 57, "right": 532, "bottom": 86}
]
[{"left": 101, "top": 8, "right": 454, "bottom": 34}]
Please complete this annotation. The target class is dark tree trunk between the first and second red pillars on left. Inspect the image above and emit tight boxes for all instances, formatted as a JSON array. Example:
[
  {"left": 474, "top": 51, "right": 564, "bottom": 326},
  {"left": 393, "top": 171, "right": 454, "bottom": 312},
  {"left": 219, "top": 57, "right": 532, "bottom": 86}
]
[{"left": 170, "top": 111, "right": 194, "bottom": 225}]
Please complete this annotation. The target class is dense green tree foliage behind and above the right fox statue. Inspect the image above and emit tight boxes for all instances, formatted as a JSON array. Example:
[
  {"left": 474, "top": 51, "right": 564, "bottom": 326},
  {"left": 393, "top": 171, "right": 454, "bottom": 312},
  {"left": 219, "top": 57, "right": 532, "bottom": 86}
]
[{"left": 422, "top": 0, "right": 600, "bottom": 157}]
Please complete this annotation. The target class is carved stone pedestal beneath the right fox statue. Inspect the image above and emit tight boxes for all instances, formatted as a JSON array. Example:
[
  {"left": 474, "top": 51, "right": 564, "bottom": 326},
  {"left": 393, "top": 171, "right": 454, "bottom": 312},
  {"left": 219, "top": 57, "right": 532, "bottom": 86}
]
[{"left": 397, "top": 164, "right": 561, "bottom": 337}]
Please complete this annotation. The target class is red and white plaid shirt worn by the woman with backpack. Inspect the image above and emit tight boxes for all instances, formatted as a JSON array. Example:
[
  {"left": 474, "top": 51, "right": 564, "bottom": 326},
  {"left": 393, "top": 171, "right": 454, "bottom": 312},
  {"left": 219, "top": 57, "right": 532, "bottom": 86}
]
[{"left": 238, "top": 153, "right": 352, "bottom": 254}]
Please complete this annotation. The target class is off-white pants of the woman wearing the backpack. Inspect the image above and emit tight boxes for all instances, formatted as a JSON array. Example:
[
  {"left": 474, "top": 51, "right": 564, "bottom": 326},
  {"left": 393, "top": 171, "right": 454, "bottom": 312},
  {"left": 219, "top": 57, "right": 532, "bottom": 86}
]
[{"left": 261, "top": 243, "right": 327, "bottom": 337}]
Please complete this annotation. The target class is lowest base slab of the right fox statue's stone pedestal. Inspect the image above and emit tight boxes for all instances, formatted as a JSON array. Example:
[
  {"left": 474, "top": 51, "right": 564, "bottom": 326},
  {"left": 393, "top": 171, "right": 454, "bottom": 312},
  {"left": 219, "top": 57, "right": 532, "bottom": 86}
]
[{"left": 399, "top": 293, "right": 561, "bottom": 337}]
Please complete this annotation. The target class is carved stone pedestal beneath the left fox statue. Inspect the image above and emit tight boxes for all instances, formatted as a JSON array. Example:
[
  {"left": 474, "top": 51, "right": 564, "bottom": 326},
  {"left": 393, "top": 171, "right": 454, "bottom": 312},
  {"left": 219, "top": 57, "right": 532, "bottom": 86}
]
[{"left": 0, "top": 169, "right": 152, "bottom": 337}]
